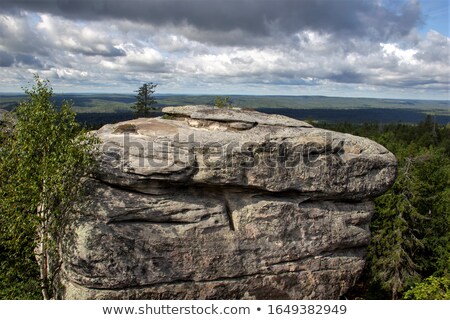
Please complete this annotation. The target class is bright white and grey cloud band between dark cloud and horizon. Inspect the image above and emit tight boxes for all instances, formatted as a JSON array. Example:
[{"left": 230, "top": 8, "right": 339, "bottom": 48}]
[{"left": 0, "top": 1, "right": 450, "bottom": 97}]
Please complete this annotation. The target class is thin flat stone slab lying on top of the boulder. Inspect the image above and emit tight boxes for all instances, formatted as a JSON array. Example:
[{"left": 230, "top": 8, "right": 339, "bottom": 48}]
[{"left": 162, "top": 105, "right": 312, "bottom": 128}]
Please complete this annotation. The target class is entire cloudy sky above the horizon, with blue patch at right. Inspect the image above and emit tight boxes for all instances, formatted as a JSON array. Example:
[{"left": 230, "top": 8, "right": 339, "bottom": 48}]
[{"left": 0, "top": 0, "right": 450, "bottom": 100}]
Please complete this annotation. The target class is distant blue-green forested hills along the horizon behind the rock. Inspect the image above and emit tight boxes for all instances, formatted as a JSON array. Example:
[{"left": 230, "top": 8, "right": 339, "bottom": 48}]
[{"left": 0, "top": 94, "right": 450, "bottom": 124}]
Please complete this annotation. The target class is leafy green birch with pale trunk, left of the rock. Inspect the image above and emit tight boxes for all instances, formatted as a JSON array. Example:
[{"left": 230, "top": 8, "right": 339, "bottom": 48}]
[{"left": 0, "top": 76, "right": 97, "bottom": 299}]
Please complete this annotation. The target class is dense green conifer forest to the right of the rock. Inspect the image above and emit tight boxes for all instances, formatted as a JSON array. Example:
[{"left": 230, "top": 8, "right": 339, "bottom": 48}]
[{"left": 323, "top": 117, "right": 450, "bottom": 299}]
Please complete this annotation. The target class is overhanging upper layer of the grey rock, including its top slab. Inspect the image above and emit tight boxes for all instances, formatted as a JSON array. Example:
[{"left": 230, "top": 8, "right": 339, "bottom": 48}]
[{"left": 97, "top": 106, "right": 397, "bottom": 199}]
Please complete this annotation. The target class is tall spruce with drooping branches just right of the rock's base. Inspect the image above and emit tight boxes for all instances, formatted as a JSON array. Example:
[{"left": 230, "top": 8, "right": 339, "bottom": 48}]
[{"left": 369, "top": 159, "right": 424, "bottom": 299}]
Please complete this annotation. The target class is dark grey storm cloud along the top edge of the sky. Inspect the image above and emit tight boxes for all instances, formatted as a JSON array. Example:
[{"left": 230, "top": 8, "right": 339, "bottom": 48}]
[{"left": 0, "top": 0, "right": 421, "bottom": 39}]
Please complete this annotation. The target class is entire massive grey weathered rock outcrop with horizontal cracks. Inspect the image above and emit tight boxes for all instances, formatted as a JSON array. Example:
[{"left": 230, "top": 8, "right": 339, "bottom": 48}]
[{"left": 61, "top": 106, "right": 396, "bottom": 299}]
